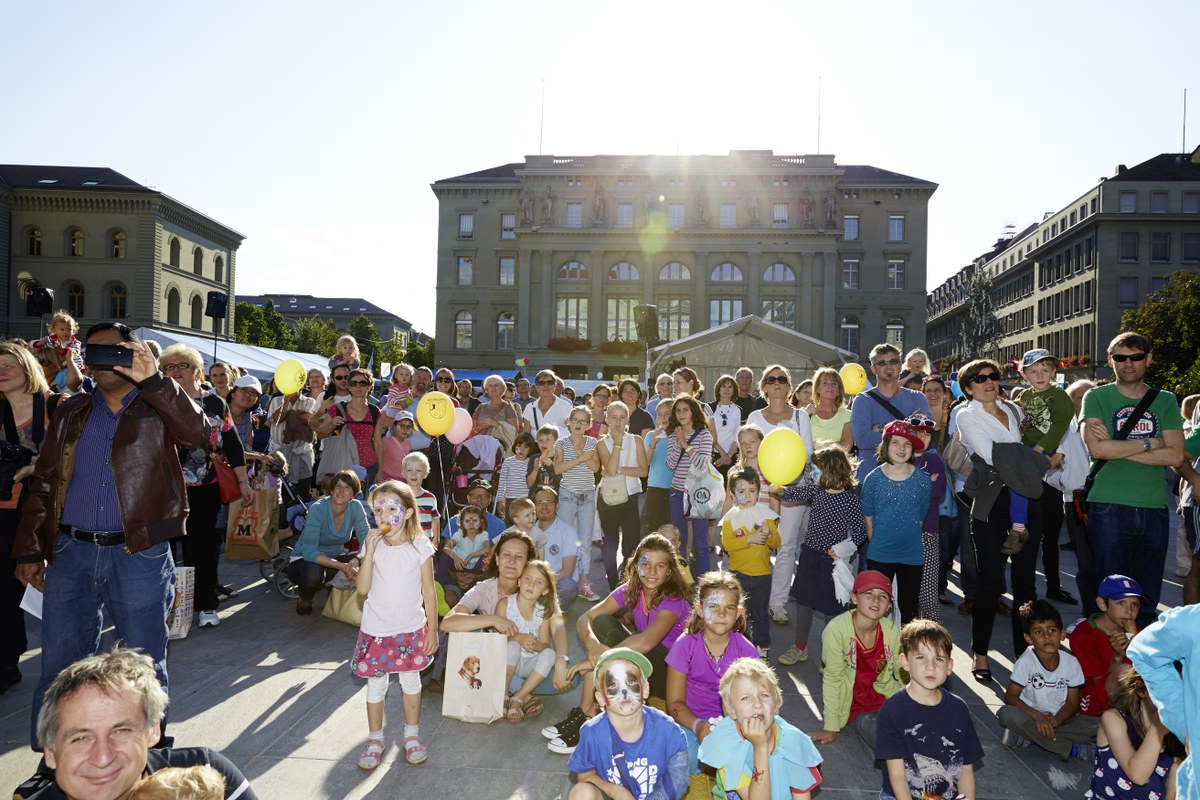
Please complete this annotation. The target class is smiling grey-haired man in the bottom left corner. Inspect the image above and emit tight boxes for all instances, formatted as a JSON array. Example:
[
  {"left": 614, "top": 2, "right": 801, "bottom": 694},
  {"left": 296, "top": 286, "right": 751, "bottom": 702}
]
[{"left": 18, "top": 648, "right": 257, "bottom": 800}]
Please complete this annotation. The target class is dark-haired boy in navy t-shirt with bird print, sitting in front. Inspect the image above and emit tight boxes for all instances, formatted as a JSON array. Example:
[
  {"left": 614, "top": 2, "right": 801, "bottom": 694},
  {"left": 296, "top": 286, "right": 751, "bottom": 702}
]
[{"left": 875, "top": 619, "right": 983, "bottom": 800}]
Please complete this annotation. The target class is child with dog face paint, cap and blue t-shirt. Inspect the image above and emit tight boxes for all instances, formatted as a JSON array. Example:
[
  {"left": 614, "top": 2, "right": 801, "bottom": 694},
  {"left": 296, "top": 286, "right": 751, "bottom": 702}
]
[{"left": 566, "top": 648, "right": 689, "bottom": 800}]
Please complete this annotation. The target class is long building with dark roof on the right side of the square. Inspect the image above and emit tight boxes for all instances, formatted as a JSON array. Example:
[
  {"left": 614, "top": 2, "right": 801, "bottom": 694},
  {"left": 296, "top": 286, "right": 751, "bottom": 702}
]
[{"left": 928, "top": 149, "right": 1200, "bottom": 379}]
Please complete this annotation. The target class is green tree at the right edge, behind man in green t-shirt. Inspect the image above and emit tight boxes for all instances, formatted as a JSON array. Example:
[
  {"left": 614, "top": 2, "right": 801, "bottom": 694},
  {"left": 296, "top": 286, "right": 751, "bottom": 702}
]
[{"left": 1118, "top": 270, "right": 1200, "bottom": 397}]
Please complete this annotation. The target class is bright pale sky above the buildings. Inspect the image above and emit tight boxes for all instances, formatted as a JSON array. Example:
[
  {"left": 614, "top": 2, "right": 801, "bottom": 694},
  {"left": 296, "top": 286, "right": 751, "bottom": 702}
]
[{"left": 0, "top": 0, "right": 1200, "bottom": 335}]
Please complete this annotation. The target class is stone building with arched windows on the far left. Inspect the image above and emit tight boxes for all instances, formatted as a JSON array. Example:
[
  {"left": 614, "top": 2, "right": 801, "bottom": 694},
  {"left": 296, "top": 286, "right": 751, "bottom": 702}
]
[{"left": 0, "top": 166, "right": 245, "bottom": 338}]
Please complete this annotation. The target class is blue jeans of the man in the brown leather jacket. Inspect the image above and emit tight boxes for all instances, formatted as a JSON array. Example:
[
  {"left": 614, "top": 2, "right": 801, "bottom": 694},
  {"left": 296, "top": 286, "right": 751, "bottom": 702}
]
[{"left": 30, "top": 533, "right": 175, "bottom": 750}]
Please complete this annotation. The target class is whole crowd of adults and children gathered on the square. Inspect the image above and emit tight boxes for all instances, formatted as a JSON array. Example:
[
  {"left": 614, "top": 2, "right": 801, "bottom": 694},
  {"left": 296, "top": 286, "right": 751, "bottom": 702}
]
[{"left": 0, "top": 313, "right": 1200, "bottom": 799}]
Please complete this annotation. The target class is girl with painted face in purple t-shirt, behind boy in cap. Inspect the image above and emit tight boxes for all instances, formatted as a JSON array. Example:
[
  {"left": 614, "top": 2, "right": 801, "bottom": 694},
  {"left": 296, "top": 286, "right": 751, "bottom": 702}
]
[{"left": 666, "top": 572, "right": 758, "bottom": 775}]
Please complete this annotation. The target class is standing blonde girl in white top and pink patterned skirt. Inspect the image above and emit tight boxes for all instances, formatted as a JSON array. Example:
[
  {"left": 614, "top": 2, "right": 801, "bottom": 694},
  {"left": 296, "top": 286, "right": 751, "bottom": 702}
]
[{"left": 350, "top": 481, "right": 438, "bottom": 770}]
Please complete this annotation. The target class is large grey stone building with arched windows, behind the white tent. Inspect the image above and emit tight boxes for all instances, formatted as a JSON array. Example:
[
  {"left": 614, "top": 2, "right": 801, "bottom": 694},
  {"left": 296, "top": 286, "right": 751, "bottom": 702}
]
[{"left": 432, "top": 150, "right": 937, "bottom": 378}]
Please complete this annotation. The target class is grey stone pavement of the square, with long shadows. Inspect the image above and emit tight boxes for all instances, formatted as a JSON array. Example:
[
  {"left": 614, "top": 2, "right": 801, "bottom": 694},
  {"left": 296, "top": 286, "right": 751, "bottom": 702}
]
[{"left": 0, "top": 524, "right": 1182, "bottom": 800}]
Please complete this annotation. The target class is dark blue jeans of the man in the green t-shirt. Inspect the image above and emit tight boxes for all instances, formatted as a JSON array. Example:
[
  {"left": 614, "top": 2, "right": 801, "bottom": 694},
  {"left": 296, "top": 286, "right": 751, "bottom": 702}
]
[{"left": 1087, "top": 503, "right": 1170, "bottom": 627}]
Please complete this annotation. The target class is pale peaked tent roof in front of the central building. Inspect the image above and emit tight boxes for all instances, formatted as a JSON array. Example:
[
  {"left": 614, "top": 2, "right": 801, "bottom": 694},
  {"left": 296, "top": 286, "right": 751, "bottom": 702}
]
[{"left": 646, "top": 315, "right": 858, "bottom": 388}]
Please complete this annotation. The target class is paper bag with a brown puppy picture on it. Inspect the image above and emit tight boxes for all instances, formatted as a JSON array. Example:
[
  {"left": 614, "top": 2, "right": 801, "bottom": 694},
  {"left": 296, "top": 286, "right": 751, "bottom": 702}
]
[{"left": 442, "top": 631, "right": 509, "bottom": 724}]
